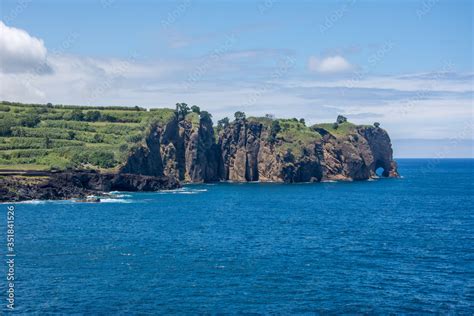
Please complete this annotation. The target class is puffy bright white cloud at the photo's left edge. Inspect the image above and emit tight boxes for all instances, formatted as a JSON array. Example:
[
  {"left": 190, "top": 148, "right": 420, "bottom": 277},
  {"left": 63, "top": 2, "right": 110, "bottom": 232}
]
[{"left": 0, "top": 21, "right": 51, "bottom": 74}]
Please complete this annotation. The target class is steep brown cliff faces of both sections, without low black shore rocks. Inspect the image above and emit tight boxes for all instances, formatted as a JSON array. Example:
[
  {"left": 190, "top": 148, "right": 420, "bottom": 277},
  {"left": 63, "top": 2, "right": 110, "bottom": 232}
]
[{"left": 121, "top": 117, "right": 398, "bottom": 183}]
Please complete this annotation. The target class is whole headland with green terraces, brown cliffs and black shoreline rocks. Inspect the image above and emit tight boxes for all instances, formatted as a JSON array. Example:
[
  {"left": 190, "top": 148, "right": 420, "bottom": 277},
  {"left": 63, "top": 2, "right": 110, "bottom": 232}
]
[{"left": 0, "top": 102, "right": 398, "bottom": 201}]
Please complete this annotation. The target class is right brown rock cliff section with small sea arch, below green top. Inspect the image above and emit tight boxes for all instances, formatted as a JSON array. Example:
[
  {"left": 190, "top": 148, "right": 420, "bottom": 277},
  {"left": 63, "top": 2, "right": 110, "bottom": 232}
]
[{"left": 215, "top": 120, "right": 398, "bottom": 182}]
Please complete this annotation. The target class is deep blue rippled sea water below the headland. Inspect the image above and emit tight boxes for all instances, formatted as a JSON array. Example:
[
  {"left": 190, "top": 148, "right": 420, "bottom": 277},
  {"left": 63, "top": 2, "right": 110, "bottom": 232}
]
[{"left": 0, "top": 160, "right": 474, "bottom": 315}]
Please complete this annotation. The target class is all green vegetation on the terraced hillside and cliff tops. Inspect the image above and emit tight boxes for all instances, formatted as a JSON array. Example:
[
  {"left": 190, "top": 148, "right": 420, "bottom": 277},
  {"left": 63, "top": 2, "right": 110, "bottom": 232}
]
[{"left": 0, "top": 101, "right": 368, "bottom": 170}]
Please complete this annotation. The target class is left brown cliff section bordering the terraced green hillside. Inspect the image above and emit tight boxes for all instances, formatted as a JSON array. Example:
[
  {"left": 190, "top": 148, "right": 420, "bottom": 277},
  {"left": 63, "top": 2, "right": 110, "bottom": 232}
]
[{"left": 120, "top": 113, "right": 220, "bottom": 182}]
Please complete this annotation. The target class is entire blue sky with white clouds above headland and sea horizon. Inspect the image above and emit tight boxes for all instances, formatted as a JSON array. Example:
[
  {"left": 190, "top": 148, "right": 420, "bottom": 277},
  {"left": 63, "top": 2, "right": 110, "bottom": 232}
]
[{"left": 0, "top": 0, "right": 474, "bottom": 158}]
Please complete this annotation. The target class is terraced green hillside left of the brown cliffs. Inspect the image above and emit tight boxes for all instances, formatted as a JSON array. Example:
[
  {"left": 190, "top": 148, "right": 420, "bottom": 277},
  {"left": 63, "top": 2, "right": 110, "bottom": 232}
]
[{"left": 0, "top": 102, "right": 174, "bottom": 170}]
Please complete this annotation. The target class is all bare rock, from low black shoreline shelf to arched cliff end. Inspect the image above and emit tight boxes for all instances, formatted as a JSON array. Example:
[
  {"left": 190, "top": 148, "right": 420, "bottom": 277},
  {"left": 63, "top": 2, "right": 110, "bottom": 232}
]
[{"left": 0, "top": 113, "right": 398, "bottom": 201}]
